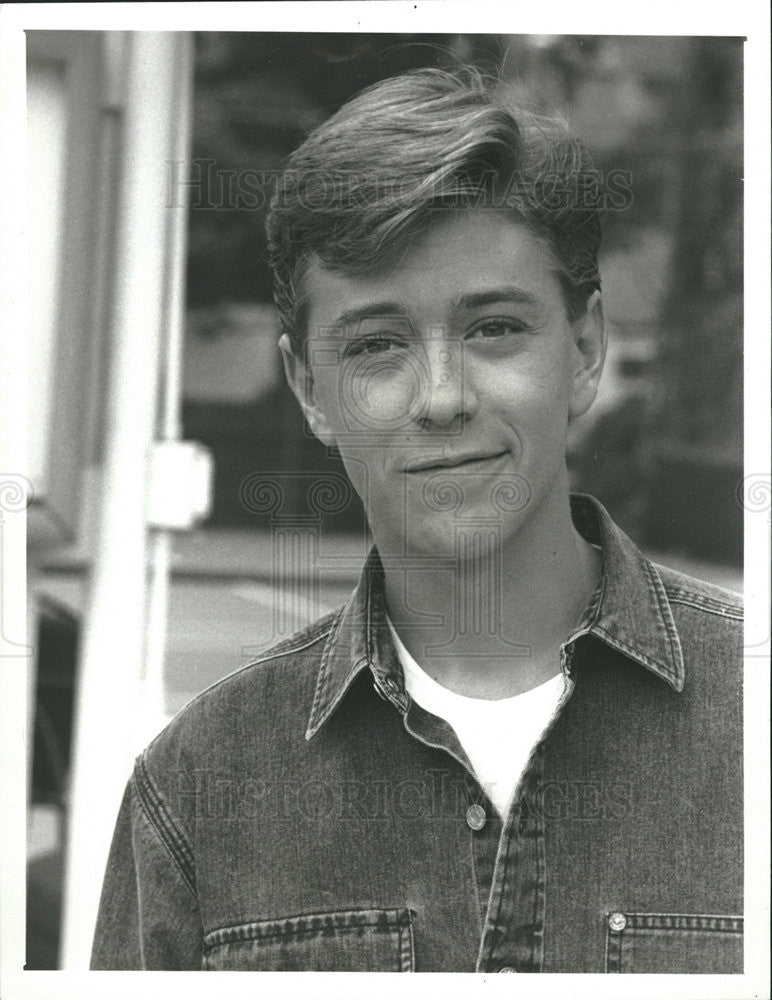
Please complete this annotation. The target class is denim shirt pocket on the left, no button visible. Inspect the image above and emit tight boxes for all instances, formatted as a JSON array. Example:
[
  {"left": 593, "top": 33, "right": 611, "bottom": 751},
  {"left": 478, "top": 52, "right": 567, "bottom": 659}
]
[{"left": 203, "top": 909, "right": 415, "bottom": 972}]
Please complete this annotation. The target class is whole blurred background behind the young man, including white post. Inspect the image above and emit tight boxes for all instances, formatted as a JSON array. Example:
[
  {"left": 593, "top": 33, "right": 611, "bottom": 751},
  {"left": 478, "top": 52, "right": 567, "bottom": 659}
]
[{"left": 27, "top": 32, "right": 742, "bottom": 969}]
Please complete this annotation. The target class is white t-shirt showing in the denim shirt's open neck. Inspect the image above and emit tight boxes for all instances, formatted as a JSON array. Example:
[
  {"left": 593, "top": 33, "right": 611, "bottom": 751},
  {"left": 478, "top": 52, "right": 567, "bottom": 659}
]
[{"left": 389, "top": 622, "right": 565, "bottom": 818}]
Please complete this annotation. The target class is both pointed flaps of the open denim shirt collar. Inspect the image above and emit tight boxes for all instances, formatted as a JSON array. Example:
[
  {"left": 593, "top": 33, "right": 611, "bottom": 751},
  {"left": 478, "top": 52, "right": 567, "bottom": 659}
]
[{"left": 306, "top": 494, "right": 684, "bottom": 739}]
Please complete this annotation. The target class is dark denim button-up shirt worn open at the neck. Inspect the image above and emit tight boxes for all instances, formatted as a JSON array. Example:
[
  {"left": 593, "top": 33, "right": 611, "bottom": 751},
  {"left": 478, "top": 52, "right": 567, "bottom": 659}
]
[{"left": 92, "top": 496, "right": 743, "bottom": 973}]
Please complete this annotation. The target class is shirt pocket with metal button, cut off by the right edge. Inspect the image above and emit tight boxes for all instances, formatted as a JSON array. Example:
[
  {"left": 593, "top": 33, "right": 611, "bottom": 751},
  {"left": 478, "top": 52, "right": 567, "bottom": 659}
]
[{"left": 606, "top": 912, "right": 743, "bottom": 974}]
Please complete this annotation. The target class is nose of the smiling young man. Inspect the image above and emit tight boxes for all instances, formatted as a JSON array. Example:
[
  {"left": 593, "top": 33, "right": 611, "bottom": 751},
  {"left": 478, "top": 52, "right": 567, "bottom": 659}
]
[{"left": 415, "top": 338, "right": 478, "bottom": 428}]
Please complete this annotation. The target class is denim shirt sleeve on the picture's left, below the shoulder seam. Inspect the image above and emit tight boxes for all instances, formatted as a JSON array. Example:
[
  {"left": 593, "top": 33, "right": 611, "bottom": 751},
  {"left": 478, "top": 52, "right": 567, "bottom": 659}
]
[{"left": 91, "top": 772, "right": 203, "bottom": 971}]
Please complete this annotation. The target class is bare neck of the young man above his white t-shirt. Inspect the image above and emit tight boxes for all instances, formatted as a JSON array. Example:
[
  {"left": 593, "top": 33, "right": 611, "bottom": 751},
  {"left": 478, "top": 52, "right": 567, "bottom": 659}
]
[{"left": 385, "top": 487, "right": 600, "bottom": 699}]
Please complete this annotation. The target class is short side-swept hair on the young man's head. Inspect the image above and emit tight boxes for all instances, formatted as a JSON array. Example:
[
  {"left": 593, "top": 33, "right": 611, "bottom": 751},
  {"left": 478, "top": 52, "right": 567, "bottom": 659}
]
[{"left": 266, "top": 66, "right": 600, "bottom": 356}]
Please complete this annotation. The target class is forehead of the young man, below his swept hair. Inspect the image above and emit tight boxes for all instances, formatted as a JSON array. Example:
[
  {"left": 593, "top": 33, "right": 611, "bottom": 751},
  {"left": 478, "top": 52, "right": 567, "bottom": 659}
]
[{"left": 304, "top": 210, "right": 563, "bottom": 334}]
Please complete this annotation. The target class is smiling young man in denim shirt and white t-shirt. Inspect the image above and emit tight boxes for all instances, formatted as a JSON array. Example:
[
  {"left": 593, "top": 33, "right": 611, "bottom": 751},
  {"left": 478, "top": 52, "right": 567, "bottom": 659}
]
[{"left": 93, "top": 70, "right": 742, "bottom": 972}]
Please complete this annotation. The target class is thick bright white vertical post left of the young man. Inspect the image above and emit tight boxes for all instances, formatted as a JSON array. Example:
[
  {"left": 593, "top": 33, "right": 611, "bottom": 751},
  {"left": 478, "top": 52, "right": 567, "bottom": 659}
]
[{"left": 61, "top": 32, "right": 193, "bottom": 969}]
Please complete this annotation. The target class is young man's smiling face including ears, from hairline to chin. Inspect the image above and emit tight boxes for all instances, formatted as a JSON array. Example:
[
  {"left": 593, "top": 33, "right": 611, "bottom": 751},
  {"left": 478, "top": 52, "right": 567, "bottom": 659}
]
[{"left": 282, "top": 210, "right": 605, "bottom": 556}]
